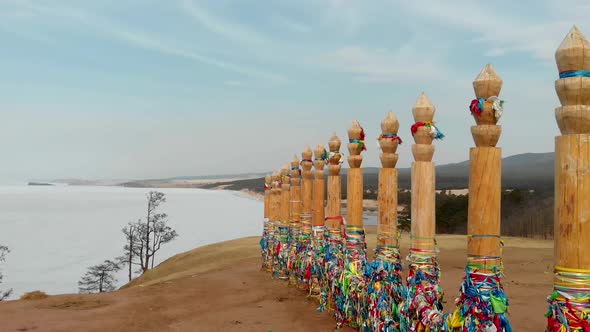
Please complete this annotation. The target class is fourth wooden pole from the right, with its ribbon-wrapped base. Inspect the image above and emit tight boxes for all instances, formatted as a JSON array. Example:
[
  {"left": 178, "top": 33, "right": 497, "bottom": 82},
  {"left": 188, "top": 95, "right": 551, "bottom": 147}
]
[{"left": 369, "top": 112, "right": 403, "bottom": 331}]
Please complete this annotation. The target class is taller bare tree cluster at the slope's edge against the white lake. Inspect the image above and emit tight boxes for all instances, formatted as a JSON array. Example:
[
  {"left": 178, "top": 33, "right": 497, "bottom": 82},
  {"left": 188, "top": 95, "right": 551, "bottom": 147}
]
[{"left": 119, "top": 191, "right": 178, "bottom": 281}]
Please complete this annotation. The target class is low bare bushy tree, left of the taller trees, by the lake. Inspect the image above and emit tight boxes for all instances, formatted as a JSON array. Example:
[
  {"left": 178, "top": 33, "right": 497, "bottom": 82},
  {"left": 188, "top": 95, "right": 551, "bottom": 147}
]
[{"left": 78, "top": 259, "right": 121, "bottom": 293}]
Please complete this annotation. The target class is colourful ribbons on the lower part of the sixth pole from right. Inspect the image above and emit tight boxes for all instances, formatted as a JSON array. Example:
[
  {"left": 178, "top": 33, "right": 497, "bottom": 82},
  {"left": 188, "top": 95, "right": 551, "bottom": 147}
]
[{"left": 317, "top": 216, "right": 345, "bottom": 312}]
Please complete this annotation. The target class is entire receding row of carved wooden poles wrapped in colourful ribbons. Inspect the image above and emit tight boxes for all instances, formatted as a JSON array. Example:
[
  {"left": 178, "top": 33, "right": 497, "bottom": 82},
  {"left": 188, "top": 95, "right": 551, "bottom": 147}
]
[{"left": 260, "top": 27, "right": 590, "bottom": 332}]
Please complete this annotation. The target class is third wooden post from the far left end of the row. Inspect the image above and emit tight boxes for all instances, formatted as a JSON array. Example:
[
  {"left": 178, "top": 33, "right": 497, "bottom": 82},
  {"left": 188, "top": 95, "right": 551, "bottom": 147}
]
[{"left": 275, "top": 165, "right": 290, "bottom": 280}]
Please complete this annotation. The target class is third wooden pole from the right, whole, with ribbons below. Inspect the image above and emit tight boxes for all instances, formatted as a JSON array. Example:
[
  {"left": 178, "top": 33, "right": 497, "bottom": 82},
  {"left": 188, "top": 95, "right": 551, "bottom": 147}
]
[{"left": 402, "top": 93, "right": 444, "bottom": 331}]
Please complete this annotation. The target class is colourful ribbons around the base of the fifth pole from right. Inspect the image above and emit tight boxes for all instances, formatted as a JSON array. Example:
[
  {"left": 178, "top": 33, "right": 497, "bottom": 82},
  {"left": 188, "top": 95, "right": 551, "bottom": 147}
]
[{"left": 334, "top": 225, "right": 368, "bottom": 329}]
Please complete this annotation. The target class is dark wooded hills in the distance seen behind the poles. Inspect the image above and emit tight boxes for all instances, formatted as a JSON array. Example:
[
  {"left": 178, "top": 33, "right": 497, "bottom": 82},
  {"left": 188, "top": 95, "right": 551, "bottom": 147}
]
[{"left": 202, "top": 172, "right": 553, "bottom": 239}]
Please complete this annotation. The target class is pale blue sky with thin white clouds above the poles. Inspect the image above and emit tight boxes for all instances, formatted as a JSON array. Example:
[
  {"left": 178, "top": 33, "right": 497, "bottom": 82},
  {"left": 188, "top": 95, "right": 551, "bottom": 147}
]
[{"left": 0, "top": 0, "right": 590, "bottom": 183}]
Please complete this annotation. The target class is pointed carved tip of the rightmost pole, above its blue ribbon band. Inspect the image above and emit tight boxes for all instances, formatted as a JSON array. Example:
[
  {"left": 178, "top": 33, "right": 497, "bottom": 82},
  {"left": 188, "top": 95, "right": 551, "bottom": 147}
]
[{"left": 555, "top": 25, "right": 590, "bottom": 73}]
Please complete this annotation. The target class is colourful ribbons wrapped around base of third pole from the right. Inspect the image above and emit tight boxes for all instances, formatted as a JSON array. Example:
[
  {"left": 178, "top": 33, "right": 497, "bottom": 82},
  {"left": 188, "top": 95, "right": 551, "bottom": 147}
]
[{"left": 400, "top": 239, "right": 444, "bottom": 332}]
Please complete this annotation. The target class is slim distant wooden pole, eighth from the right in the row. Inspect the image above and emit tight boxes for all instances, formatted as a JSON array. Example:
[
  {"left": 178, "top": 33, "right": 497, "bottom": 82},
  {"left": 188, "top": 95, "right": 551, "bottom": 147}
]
[{"left": 297, "top": 146, "right": 313, "bottom": 290}]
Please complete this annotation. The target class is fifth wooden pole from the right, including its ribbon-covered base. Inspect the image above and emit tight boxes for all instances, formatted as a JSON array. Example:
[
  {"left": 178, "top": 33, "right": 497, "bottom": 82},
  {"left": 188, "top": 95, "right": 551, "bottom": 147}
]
[{"left": 335, "top": 120, "right": 368, "bottom": 329}]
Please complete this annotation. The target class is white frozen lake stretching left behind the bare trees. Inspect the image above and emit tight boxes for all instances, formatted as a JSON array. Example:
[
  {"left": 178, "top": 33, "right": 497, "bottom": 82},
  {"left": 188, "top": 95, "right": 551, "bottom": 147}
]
[{"left": 0, "top": 186, "right": 263, "bottom": 298}]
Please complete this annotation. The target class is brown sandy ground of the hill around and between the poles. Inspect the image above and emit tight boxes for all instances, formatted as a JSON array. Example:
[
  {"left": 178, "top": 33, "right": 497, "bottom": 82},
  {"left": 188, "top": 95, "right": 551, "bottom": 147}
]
[{"left": 0, "top": 231, "right": 553, "bottom": 332}]
